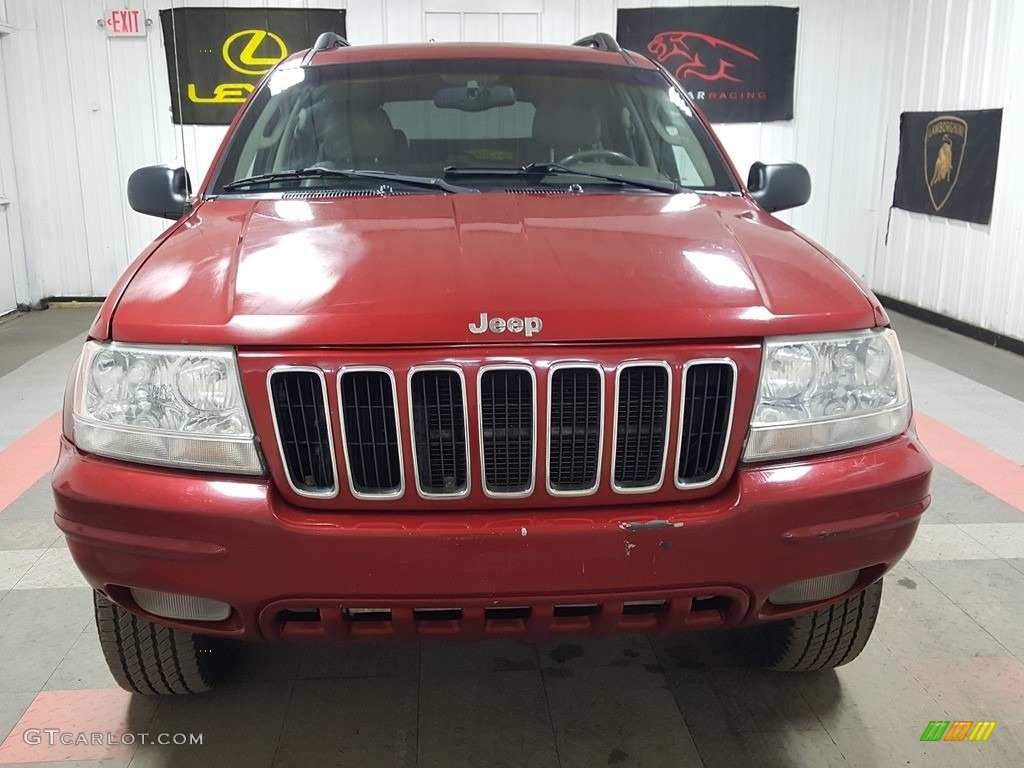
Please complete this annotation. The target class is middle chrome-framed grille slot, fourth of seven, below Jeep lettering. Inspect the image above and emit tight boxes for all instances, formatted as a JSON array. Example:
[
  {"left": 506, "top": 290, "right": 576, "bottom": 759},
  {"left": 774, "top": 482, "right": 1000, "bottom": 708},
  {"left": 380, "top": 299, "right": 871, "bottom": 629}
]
[{"left": 480, "top": 368, "right": 537, "bottom": 496}]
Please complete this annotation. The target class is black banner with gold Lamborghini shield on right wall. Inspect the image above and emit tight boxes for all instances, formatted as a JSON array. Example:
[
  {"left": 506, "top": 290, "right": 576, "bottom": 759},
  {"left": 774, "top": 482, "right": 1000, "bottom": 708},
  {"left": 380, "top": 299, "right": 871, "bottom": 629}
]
[{"left": 893, "top": 110, "right": 1002, "bottom": 224}]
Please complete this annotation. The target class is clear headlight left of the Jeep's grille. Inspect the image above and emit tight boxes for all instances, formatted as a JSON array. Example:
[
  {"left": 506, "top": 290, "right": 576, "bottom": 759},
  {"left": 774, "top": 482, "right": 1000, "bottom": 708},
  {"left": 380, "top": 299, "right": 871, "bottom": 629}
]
[{"left": 75, "top": 341, "right": 263, "bottom": 474}]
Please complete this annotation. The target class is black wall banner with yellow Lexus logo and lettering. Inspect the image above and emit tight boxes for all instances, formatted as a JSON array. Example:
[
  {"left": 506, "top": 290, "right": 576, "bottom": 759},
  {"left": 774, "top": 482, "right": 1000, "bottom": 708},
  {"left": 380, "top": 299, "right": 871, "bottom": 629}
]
[{"left": 160, "top": 8, "right": 345, "bottom": 125}]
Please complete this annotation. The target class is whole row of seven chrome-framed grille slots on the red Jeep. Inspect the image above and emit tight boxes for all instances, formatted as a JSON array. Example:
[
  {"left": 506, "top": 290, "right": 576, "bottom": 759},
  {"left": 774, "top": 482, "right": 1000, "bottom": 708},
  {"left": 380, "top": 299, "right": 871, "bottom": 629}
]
[{"left": 267, "top": 357, "right": 737, "bottom": 500}]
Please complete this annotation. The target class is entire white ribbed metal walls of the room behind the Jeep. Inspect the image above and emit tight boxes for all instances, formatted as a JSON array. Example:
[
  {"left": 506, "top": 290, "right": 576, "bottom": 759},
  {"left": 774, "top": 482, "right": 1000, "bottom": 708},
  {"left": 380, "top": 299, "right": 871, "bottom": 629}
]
[{"left": 0, "top": 0, "right": 1024, "bottom": 338}]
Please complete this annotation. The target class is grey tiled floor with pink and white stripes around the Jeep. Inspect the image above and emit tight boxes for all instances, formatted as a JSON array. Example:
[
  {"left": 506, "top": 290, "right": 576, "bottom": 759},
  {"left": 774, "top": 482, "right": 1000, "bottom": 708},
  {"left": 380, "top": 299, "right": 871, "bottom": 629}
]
[{"left": 0, "top": 307, "right": 1024, "bottom": 768}]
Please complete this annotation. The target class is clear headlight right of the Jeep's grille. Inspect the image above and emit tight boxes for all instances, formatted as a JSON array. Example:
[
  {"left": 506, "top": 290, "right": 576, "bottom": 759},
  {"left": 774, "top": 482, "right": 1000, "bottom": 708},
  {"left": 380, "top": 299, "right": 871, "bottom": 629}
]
[{"left": 743, "top": 329, "right": 910, "bottom": 462}]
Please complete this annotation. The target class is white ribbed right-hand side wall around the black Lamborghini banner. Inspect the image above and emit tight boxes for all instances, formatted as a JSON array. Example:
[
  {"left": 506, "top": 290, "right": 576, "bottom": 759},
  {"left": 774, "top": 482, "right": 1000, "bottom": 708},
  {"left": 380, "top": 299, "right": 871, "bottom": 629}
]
[{"left": 870, "top": 0, "right": 1024, "bottom": 338}]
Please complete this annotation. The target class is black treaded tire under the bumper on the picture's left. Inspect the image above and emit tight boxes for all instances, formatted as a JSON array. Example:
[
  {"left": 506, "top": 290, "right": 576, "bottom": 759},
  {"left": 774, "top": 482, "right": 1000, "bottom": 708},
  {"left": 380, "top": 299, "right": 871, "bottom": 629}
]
[{"left": 93, "top": 592, "right": 241, "bottom": 696}]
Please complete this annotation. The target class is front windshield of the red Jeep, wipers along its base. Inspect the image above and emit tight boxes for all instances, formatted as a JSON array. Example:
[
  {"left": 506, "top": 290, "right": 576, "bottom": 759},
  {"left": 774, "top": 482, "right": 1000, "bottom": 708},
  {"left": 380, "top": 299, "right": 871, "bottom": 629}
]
[{"left": 210, "top": 58, "right": 736, "bottom": 195}]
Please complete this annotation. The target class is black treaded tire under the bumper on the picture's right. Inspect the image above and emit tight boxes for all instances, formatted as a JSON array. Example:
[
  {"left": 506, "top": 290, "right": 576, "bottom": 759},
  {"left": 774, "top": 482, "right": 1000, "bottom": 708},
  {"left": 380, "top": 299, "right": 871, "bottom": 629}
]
[{"left": 751, "top": 579, "right": 882, "bottom": 672}]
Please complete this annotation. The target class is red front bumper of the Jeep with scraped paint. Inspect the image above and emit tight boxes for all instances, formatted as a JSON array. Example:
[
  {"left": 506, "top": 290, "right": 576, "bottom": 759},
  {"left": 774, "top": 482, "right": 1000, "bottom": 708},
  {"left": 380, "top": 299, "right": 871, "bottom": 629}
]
[{"left": 53, "top": 434, "right": 931, "bottom": 640}]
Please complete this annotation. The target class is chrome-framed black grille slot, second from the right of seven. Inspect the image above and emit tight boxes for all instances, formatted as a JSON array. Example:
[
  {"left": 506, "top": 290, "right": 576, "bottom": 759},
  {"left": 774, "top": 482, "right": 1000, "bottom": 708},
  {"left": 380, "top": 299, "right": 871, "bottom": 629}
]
[{"left": 612, "top": 364, "right": 670, "bottom": 493}]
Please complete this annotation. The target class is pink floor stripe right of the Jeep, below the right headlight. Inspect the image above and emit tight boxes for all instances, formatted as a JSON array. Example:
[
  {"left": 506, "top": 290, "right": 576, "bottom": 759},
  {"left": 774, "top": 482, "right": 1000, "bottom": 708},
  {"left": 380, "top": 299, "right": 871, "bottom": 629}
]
[{"left": 913, "top": 411, "right": 1024, "bottom": 512}]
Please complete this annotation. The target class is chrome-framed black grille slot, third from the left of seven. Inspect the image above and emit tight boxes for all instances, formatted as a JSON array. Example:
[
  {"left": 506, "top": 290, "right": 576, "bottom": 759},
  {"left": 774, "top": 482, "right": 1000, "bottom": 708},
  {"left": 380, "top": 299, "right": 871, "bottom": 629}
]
[{"left": 409, "top": 369, "right": 469, "bottom": 497}]
